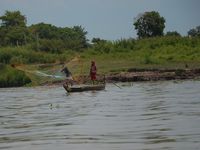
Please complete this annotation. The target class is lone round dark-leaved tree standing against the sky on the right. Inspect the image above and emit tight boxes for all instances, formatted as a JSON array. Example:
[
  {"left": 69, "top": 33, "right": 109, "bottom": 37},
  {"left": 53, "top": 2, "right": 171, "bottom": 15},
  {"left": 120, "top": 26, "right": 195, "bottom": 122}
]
[{"left": 133, "top": 11, "right": 165, "bottom": 38}]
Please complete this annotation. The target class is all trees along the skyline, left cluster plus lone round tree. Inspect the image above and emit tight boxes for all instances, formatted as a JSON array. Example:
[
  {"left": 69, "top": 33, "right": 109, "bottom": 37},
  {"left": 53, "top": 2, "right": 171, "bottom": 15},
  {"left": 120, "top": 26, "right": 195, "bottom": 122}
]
[{"left": 0, "top": 11, "right": 200, "bottom": 54}]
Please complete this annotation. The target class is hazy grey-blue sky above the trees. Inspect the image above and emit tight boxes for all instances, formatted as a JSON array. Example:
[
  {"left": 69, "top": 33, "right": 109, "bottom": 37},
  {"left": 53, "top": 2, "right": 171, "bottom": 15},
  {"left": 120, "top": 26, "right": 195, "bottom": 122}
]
[{"left": 0, "top": 0, "right": 200, "bottom": 40}]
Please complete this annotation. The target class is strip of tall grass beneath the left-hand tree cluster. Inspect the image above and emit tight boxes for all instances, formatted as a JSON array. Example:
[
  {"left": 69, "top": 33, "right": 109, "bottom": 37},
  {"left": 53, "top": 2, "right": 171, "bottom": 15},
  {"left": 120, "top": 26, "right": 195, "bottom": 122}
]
[{"left": 0, "top": 47, "right": 73, "bottom": 64}]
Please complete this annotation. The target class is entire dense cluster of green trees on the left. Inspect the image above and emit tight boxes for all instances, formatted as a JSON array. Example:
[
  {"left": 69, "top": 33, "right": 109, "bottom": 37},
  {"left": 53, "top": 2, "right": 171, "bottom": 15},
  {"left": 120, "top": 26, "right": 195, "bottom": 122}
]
[{"left": 0, "top": 11, "right": 88, "bottom": 53}]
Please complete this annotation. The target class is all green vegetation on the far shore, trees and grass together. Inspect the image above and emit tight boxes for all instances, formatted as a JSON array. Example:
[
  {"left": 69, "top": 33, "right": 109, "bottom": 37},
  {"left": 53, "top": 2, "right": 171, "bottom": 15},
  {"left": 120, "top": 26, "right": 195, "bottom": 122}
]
[{"left": 0, "top": 11, "right": 200, "bottom": 87}]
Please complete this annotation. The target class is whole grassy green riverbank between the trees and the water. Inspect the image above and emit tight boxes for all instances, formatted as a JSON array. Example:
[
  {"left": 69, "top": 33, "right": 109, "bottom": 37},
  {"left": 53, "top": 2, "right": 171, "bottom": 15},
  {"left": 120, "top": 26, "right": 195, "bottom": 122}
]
[{"left": 0, "top": 36, "right": 200, "bottom": 85}]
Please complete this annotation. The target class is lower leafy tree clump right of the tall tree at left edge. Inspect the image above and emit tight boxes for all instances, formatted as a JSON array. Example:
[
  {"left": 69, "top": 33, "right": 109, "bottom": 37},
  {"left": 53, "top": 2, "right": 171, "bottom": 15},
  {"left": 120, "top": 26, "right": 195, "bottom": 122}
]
[{"left": 29, "top": 23, "right": 88, "bottom": 53}]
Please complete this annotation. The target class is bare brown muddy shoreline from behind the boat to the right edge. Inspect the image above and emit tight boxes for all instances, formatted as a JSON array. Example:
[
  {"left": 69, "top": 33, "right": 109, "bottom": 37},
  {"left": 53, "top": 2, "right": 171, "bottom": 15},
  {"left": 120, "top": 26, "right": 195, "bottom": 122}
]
[{"left": 41, "top": 68, "right": 200, "bottom": 86}]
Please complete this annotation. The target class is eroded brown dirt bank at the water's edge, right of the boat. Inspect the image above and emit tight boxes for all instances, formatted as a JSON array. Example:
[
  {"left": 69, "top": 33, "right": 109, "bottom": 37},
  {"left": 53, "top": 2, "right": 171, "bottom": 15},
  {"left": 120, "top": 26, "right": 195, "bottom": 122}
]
[{"left": 106, "top": 68, "right": 200, "bottom": 82}]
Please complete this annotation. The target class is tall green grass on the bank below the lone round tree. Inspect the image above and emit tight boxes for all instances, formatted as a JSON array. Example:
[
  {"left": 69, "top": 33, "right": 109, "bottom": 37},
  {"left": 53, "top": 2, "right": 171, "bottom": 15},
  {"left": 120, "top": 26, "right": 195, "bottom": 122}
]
[{"left": 76, "top": 36, "right": 200, "bottom": 73}]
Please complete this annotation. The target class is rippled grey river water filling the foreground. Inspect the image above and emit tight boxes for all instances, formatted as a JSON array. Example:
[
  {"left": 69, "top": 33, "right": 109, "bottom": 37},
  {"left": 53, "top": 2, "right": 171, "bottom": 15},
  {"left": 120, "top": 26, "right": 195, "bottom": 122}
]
[{"left": 0, "top": 81, "right": 200, "bottom": 150}]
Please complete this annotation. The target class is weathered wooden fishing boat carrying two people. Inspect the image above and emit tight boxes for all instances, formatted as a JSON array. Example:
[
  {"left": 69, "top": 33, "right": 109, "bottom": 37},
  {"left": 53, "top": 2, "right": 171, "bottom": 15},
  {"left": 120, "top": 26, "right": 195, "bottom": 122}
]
[{"left": 63, "top": 83, "right": 105, "bottom": 92}]
